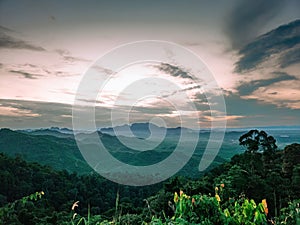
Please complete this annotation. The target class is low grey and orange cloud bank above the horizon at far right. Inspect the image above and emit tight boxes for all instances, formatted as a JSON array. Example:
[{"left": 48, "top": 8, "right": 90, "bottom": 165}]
[{"left": 220, "top": 91, "right": 300, "bottom": 127}]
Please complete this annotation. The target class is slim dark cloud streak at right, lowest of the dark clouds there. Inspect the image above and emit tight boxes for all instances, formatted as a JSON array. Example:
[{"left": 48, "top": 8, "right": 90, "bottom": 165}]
[{"left": 237, "top": 72, "right": 297, "bottom": 96}]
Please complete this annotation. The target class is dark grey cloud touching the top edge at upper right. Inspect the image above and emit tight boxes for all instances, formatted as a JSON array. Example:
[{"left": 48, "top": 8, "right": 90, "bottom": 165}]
[{"left": 225, "top": 0, "right": 285, "bottom": 49}]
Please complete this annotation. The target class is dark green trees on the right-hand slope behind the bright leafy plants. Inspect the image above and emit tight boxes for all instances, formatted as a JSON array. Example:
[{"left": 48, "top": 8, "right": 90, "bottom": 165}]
[{"left": 182, "top": 144, "right": 300, "bottom": 216}]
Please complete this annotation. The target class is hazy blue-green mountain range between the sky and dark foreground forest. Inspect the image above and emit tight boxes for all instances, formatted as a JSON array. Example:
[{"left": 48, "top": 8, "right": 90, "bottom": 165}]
[{"left": 0, "top": 123, "right": 300, "bottom": 177}]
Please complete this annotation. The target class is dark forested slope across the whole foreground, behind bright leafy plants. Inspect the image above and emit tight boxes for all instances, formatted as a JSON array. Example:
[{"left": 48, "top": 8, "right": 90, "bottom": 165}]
[{"left": 0, "top": 141, "right": 300, "bottom": 224}]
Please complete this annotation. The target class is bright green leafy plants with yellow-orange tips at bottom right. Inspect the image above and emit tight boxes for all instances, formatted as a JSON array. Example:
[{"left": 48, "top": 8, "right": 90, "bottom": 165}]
[{"left": 151, "top": 188, "right": 267, "bottom": 225}]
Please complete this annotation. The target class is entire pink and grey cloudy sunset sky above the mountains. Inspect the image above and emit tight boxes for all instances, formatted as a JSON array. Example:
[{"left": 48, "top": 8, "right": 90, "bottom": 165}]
[{"left": 0, "top": 0, "right": 300, "bottom": 129}]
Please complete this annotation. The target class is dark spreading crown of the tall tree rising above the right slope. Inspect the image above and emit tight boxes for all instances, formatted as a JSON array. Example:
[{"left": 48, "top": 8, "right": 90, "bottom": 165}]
[{"left": 239, "top": 130, "right": 277, "bottom": 153}]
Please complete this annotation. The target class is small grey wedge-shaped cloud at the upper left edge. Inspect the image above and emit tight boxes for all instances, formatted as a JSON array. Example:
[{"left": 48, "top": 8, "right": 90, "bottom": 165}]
[{"left": 0, "top": 26, "right": 45, "bottom": 51}]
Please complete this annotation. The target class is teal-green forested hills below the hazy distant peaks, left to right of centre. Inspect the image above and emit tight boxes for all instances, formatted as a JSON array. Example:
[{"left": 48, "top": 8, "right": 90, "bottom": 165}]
[{"left": 0, "top": 129, "right": 227, "bottom": 177}]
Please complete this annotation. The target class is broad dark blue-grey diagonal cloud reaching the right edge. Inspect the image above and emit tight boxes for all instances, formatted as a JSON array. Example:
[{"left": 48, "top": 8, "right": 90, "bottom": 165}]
[{"left": 235, "top": 20, "right": 300, "bottom": 72}]
